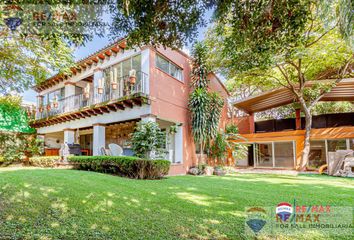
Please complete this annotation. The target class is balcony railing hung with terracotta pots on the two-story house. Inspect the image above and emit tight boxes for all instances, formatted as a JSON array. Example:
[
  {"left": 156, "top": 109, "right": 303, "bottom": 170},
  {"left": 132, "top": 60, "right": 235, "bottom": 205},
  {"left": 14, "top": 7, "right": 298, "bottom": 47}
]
[{"left": 36, "top": 72, "right": 148, "bottom": 119}]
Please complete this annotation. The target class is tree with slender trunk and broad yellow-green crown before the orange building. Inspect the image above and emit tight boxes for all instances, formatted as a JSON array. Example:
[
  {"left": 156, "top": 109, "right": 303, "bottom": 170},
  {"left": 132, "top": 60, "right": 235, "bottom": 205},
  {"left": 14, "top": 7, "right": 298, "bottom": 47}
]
[{"left": 207, "top": 1, "right": 353, "bottom": 169}]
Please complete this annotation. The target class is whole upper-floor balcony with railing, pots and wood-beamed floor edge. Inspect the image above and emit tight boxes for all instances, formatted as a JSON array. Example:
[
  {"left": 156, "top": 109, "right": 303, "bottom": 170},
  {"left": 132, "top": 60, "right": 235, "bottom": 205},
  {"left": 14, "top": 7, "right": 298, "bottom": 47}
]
[{"left": 33, "top": 72, "right": 148, "bottom": 125}]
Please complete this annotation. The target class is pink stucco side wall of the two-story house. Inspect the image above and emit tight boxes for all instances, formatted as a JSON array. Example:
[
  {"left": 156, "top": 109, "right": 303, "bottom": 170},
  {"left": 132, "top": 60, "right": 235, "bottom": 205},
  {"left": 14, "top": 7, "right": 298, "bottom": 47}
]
[{"left": 150, "top": 48, "right": 228, "bottom": 175}]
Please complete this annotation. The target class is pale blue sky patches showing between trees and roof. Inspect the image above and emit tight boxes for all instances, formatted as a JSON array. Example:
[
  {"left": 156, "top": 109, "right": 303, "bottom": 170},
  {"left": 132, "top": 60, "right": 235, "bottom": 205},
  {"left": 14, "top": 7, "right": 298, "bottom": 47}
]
[{"left": 21, "top": 10, "right": 212, "bottom": 103}]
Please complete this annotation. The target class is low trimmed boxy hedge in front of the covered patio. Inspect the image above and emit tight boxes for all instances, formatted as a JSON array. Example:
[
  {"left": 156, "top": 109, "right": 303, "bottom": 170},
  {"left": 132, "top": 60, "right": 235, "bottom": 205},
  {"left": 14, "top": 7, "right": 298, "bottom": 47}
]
[{"left": 68, "top": 156, "right": 170, "bottom": 179}]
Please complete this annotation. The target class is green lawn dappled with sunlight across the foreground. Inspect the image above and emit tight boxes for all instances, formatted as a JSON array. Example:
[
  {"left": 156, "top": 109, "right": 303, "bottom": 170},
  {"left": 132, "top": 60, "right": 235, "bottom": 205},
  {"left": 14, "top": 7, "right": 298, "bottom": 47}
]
[{"left": 0, "top": 169, "right": 354, "bottom": 239}]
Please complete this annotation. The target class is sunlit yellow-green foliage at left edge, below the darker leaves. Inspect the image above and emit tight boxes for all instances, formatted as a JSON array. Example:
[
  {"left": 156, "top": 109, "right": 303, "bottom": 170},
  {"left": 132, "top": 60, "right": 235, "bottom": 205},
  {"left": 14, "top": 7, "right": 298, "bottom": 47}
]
[{"left": 0, "top": 36, "right": 73, "bottom": 94}]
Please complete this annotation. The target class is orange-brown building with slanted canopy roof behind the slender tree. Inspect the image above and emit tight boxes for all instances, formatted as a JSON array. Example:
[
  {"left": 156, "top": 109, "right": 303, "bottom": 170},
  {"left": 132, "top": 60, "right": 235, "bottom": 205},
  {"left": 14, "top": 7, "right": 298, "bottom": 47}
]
[{"left": 234, "top": 78, "right": 354, "bottom": 169}]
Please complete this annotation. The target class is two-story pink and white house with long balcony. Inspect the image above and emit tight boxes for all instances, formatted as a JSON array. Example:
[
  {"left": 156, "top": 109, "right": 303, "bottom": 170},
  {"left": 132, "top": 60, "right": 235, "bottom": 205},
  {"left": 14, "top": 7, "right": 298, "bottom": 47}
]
[{"left": 32, "top": 39, "right": 228, "bottom": 174}]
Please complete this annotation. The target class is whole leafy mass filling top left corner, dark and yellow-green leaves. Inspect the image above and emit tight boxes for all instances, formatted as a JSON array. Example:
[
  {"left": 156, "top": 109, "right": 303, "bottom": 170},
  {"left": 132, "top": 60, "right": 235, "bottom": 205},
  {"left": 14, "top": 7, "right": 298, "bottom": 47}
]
[{"left": 0, "top": 0, "right": 106, "bottom": 94}]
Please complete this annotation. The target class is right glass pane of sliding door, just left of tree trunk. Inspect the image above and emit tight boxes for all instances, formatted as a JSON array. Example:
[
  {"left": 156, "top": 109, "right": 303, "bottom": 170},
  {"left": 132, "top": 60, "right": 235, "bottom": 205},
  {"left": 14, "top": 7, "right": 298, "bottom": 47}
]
[{"left": 274, "top": 142, "right": 294, "bottom": 168}]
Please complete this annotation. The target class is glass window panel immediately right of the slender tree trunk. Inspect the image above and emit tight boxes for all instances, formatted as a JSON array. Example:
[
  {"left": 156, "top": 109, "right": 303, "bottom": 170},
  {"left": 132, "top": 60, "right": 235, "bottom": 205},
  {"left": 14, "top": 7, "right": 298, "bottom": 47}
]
[{"left": 308, "top": 140, "right": 326, "bottom": 169}]
